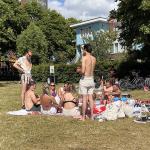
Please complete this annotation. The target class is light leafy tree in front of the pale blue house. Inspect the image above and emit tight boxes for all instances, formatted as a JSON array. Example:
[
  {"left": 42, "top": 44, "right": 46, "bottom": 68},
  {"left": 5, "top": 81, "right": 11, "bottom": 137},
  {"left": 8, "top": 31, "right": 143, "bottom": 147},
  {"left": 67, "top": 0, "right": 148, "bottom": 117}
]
[{"left": 85, "top": 31, "right": 116, "bottom": 60}]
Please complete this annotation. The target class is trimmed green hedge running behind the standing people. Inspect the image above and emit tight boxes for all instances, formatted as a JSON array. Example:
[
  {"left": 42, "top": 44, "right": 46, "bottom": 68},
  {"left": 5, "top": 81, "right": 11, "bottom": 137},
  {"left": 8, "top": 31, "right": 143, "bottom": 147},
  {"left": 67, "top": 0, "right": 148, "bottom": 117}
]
[{"left": 32, "top": 61, "right": 116, "bottom": 83}]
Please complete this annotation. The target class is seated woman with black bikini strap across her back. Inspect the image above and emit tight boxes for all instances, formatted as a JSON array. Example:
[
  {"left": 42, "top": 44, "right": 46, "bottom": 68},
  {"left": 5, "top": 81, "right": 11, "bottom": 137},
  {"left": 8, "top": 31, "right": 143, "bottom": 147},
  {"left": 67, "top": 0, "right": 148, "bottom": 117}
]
[{"left": 62, "top": 84, "right": 80, "bottom": 117}]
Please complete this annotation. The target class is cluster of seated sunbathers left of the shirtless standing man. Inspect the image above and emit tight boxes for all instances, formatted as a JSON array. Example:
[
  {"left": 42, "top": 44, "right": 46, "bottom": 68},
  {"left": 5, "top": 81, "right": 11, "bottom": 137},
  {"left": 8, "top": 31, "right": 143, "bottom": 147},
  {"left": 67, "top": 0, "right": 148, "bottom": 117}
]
[{"left": 25, "top": 81, "right": 80, "bottom": 116}]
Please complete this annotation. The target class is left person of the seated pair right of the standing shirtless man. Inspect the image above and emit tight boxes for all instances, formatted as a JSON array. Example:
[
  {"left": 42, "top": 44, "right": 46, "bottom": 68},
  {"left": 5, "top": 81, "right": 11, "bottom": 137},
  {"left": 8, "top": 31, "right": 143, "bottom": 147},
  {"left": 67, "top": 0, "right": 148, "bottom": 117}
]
[{"left": 103, "top": 81, "right": 113, "bottom": 105}]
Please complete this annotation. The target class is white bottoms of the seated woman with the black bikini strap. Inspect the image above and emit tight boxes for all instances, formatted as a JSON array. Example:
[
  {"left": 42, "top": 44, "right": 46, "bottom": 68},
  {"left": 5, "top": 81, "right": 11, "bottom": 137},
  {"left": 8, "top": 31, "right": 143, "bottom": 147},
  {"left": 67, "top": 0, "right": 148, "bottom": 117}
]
[{"left": 63, "top": 107, "right": 80, "bottom": 117}]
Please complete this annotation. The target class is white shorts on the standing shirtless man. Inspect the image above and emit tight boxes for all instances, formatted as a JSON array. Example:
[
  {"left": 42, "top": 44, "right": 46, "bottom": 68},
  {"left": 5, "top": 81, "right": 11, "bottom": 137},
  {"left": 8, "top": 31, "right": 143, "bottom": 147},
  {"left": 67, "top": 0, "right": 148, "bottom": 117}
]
[{"left": 79, "top": 77, "right": 95, "bottom": 95}]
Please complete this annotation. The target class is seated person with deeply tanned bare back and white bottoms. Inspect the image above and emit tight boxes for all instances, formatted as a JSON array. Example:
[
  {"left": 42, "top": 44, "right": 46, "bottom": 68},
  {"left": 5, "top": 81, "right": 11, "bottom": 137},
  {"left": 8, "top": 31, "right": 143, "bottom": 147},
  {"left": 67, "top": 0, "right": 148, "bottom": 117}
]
[{"left": 40, "top": 85, "right": 59, "bottom": 114}]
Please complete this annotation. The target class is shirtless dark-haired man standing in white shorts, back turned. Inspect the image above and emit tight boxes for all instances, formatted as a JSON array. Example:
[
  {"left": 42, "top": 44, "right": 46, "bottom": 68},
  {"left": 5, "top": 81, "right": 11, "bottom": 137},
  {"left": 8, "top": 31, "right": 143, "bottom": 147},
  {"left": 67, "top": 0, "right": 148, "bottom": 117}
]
[{"left": 79, "top": 44, "right": 96, "bottom": 120}]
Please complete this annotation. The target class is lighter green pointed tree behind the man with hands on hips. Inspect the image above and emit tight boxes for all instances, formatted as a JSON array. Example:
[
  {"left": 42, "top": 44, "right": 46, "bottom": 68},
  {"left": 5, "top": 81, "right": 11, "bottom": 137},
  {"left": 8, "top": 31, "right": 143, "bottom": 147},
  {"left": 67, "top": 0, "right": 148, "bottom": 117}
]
[{"left": 17, "top": 22, "right": 48, "bottom": 64}]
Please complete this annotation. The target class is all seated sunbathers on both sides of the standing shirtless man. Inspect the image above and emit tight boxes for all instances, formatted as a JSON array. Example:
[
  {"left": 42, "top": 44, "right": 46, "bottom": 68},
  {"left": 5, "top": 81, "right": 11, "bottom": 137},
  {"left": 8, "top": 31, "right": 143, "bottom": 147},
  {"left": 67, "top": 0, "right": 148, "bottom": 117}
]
[{"left": 25, "top": 78, "right": 124, "bottom": 117}]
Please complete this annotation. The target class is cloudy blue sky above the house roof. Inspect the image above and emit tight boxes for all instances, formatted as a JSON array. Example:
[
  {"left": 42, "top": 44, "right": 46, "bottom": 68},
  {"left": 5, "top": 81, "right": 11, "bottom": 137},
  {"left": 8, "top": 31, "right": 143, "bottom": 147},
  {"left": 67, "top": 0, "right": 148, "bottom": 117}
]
[{"left": 48, "top": 0, "right": 117, "bottom": 20}]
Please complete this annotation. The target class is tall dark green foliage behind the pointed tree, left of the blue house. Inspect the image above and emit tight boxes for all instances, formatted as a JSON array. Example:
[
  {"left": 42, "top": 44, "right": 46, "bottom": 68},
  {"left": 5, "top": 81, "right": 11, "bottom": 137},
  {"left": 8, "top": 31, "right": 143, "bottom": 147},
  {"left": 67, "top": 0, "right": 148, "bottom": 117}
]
[{"left": 0, "top": 0, "right": 76, "bottom": 63}]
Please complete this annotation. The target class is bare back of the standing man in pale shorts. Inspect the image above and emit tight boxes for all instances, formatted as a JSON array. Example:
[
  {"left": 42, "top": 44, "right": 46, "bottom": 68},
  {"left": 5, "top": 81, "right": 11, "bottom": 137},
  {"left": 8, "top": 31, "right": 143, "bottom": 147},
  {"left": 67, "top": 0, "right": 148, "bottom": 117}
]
[{"left": 82, "top": 55, "right": 96, "bottom": 77}]
